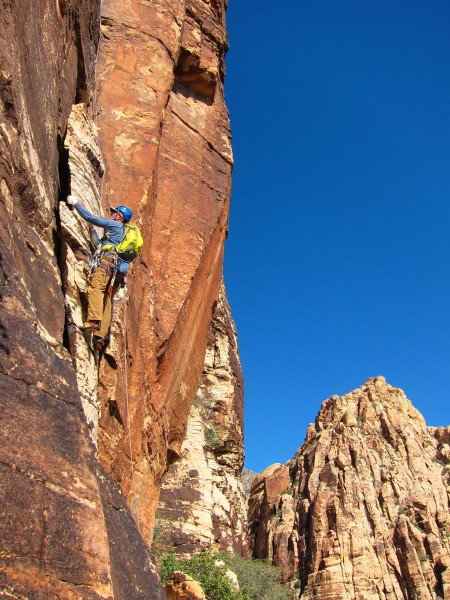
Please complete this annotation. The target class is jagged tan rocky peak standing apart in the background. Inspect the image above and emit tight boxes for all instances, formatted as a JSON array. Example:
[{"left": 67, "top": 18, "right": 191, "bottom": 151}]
[{"left": 250, "top": 377, "right": 450, "bottom": 600}]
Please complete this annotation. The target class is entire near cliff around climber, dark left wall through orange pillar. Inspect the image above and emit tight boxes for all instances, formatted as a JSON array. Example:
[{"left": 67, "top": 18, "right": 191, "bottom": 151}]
[{"left": 0, "top": 0, "right": 242, "bottom": 600}]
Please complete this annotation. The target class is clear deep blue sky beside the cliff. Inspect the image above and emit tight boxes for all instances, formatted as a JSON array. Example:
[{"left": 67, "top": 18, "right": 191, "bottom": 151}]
[{"left": 225, "top": 0, "right": 450, "bottom": 471}]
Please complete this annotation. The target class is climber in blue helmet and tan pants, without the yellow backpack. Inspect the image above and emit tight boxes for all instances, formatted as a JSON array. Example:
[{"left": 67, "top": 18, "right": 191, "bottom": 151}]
[{"left": 66, "top": 196, "right": 133, "bottom": 350}]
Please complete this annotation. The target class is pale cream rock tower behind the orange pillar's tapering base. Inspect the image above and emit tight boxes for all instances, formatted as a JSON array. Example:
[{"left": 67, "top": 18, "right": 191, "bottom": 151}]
[{"left": 154, "top": 288, "right": 247, "bottom": 553}]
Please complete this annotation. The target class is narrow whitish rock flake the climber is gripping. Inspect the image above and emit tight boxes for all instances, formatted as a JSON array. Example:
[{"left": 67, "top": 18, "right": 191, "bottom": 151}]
[{"left": 59, "top": 104, "right": 105, "bottom": 445}]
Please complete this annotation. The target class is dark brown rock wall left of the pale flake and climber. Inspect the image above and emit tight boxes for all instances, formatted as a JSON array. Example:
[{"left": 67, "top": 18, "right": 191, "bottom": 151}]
[{"left": 0, "top": 0, "right": 118, "bottom": 598}]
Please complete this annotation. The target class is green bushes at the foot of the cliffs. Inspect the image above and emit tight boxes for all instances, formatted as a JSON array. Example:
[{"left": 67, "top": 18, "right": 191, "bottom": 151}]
[{"left": 162, "top": 550, "right": 291, "bottom": 600}]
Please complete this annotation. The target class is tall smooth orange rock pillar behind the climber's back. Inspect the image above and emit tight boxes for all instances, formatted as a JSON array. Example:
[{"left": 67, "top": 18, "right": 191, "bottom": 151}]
[{"left": 97, "top": 0, "right": 232, "bottom": 540}]
